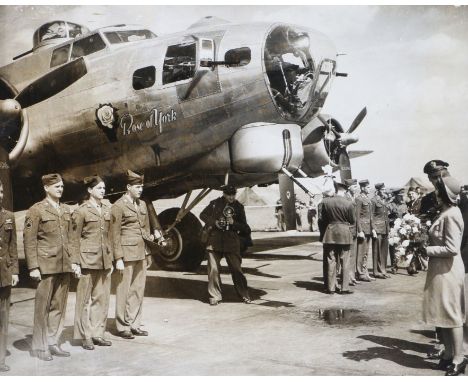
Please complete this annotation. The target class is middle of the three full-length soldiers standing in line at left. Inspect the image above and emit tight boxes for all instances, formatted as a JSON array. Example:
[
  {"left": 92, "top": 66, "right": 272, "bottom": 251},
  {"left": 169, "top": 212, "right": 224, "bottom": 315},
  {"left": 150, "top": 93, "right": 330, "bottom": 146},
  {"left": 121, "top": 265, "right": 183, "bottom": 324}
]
[{"left": 70, "top": 176, "right": 113, "bottom": 350}]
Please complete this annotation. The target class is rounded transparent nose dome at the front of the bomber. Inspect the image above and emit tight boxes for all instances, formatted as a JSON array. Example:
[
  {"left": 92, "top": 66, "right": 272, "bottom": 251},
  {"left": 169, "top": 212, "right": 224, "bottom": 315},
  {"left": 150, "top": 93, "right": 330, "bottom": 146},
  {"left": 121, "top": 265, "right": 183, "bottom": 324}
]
[{"left": 264, "top": 24, "right": 336, "bottom": 122}]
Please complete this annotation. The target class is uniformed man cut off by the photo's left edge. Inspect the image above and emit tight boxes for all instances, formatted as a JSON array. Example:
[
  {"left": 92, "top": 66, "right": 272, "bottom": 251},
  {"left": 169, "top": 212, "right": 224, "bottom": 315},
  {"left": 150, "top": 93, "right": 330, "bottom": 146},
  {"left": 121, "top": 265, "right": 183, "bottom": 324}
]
[{"left": 0, "top": 182, "right": 19, "bottom": 373}]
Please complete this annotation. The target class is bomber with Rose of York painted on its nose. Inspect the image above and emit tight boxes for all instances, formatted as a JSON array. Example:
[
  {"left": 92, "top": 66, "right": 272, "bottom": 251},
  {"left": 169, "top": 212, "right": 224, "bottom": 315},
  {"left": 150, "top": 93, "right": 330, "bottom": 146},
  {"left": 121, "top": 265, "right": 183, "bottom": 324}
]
[{"left": 0, "top": 17, "right": 367, "bottom": 270}]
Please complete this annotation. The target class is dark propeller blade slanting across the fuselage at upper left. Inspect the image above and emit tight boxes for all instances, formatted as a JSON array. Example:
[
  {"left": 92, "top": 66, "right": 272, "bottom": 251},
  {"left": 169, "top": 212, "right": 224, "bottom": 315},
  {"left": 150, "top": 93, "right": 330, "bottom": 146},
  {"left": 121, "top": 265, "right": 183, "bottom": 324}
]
[{"left": 15, "top": 57, "right": 88, "bottom": 108}]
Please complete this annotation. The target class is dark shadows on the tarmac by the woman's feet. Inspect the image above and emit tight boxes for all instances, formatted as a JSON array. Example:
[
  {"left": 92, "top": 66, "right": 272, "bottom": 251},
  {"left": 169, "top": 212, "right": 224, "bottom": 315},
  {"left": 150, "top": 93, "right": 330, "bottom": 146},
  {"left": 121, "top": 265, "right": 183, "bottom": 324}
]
[{"left": 343, "top": 335, "right": 436, "bottom": 369}]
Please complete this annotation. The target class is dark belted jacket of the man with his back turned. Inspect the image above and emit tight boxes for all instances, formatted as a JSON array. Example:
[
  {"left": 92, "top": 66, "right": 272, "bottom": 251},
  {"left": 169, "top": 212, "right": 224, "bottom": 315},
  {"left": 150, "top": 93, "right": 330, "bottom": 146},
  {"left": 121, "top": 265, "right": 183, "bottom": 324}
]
[{"left": 319, "top": 195, "right": 355, "bottom": 245}]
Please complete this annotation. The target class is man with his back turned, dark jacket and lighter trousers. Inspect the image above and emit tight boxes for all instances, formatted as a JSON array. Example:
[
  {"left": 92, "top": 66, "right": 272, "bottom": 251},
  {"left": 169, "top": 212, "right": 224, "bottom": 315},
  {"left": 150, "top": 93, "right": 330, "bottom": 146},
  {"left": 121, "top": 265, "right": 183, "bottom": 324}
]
[{"left": 319, "top": 182, "right": 355, "bottom": 294}]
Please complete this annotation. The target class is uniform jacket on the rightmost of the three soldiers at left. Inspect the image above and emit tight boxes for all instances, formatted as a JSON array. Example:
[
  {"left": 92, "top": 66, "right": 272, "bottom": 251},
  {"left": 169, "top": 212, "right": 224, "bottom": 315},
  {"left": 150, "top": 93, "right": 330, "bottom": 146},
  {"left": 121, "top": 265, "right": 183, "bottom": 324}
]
[{"left": 110, "top": 195, "right": 150, "bottom": 261}]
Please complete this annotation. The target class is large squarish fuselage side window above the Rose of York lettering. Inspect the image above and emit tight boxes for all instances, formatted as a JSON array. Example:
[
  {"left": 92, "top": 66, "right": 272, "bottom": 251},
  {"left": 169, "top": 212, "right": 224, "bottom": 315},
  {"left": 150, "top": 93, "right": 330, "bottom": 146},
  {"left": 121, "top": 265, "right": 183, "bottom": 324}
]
[{"left": 163, "top": 41, "right": 197, "bottom": 85}]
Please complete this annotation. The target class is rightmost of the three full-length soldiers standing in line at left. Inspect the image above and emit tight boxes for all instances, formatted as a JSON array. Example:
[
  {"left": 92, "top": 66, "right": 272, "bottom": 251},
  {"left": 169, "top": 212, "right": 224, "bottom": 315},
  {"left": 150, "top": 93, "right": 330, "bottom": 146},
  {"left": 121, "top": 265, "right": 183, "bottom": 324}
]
[{"left": 110, "top": 170, "right": 153, "bottom": 339}]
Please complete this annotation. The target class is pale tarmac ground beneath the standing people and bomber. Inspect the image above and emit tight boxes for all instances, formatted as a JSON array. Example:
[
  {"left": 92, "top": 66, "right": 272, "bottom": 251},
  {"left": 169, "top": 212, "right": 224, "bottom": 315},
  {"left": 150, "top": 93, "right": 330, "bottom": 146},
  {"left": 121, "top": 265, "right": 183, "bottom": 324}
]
[{"left": 0, "top": 232, "right": 454, "bottom": 375}]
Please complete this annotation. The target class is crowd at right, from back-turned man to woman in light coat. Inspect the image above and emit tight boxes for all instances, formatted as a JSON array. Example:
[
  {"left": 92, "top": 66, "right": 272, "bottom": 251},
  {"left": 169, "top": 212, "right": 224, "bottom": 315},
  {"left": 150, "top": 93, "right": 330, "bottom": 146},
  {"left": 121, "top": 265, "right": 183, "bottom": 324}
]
[{"left": 318, "top": 160, "right": 468, "bottom": 376}]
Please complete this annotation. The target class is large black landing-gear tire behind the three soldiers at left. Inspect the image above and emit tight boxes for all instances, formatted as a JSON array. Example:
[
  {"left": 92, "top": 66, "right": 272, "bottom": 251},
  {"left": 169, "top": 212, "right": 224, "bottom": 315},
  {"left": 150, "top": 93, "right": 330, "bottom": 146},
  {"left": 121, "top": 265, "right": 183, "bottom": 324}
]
[{"left": 153, "top": 208, "right": 205, "bottom": 271}]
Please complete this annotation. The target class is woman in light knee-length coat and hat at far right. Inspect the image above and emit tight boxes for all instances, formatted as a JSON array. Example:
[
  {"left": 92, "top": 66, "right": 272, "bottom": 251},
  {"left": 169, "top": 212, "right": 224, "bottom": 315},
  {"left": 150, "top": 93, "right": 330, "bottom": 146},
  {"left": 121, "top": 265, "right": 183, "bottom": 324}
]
[{"left": 423, "top": 177, "right": 466, "bottom": 375}]
